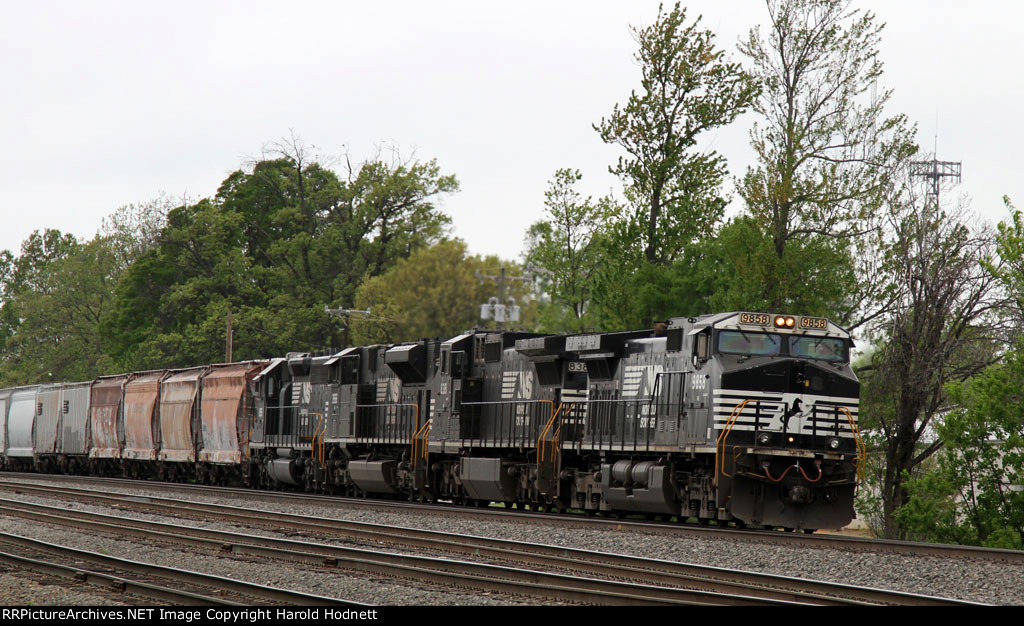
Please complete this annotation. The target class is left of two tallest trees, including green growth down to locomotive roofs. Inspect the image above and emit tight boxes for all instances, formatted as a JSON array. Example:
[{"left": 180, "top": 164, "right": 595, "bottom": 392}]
[{"left": 592, "top": 3, "right": 759, "bottom": 328}]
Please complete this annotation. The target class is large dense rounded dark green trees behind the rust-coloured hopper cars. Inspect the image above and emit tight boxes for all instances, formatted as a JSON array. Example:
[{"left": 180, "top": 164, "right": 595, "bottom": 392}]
[{"left": 106, "top": 138, "right": 458, "bottom": 369}]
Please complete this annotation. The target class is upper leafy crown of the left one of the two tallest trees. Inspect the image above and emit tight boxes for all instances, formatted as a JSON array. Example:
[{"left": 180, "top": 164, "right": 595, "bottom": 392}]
[{"left": 594, "top": 3, "right": 758, "bottom": 264}]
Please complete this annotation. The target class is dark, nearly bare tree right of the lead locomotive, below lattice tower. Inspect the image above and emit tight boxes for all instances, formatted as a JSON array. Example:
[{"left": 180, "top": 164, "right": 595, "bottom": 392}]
[{"left": 863, "top": 175, "right": 1006, "bottom": 538}]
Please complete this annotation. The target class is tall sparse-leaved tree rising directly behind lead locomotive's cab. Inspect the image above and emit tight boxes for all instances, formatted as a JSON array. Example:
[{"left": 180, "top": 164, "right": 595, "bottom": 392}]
[{"left": 739, "top": 0, "right": 916, "bottom": 327}]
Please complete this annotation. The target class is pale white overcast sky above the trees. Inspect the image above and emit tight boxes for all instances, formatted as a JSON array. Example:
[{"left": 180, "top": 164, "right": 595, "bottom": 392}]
[{"left": 0, "top": 0, "right": 1024, "bottom": 258}]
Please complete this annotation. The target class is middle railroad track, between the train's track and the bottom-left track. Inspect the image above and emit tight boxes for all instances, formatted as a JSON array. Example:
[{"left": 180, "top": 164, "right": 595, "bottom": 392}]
[{"left": 0, "top": 484, "right": 968, "bottom": 606}]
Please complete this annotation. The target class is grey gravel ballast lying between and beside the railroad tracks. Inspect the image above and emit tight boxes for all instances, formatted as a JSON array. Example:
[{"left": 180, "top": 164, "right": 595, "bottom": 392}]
[{"left": 0, "top": 478, "right": 1024, "bottom": 606}]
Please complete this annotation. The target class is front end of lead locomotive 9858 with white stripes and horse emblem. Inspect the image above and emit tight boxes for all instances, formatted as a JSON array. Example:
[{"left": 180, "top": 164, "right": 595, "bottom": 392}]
[{"left": 696, "top": 312, "right": 861, "bottom": 529}]
